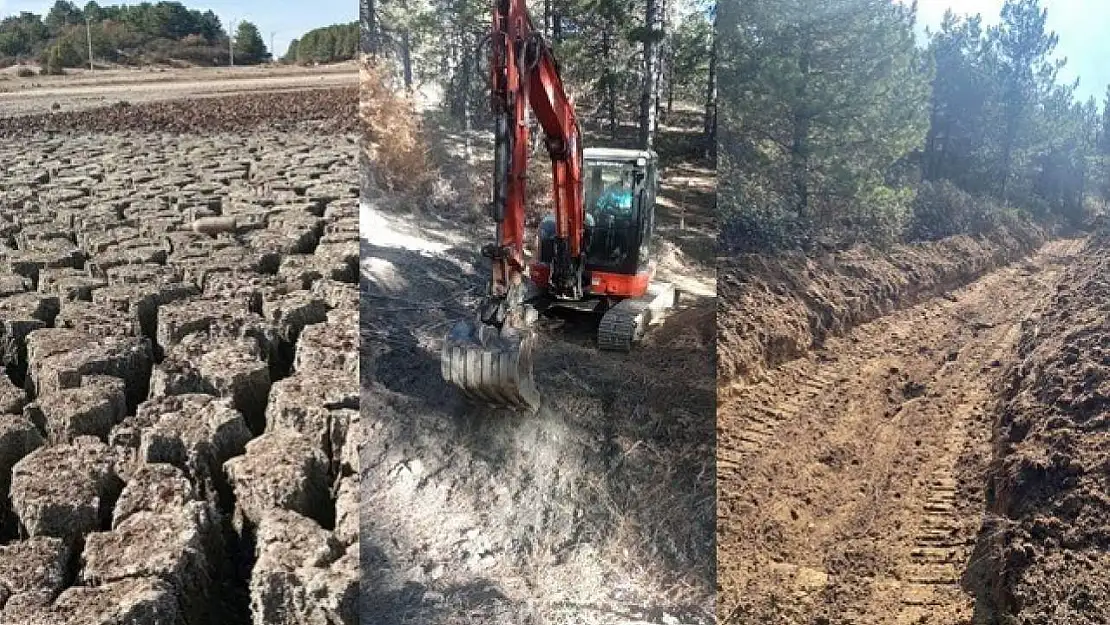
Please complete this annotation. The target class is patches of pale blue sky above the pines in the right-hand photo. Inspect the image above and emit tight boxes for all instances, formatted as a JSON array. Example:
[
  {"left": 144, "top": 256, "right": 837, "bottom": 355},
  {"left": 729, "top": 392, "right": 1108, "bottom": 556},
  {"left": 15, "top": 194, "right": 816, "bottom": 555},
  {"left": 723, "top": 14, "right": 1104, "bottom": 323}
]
[{"left": 910, "top": 0, "right": 1110, "bottom": 104}]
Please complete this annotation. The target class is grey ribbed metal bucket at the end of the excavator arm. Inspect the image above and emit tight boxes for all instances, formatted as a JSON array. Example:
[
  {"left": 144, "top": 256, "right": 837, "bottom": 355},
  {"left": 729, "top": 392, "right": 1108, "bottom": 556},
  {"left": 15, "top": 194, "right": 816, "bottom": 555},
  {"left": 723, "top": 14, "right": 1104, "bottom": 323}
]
[{"left": 442, "top": 321, "right": 539, "bottom": 412}]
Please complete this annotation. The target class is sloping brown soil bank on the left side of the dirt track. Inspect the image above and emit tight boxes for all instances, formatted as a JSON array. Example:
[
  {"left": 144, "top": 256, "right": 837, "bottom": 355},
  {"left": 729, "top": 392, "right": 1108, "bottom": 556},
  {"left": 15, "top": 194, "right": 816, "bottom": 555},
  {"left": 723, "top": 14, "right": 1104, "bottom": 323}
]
[{"left": 717, "top": 219, "right": 1045, "bottom": 387}]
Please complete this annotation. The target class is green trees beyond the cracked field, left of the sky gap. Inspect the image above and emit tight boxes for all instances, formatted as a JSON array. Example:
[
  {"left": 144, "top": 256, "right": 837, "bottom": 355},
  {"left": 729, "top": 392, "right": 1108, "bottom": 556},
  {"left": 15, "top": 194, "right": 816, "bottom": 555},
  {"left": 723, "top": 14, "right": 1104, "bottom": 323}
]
[{"left": 0, "top": 0, "right": 270, "bottom": 73}]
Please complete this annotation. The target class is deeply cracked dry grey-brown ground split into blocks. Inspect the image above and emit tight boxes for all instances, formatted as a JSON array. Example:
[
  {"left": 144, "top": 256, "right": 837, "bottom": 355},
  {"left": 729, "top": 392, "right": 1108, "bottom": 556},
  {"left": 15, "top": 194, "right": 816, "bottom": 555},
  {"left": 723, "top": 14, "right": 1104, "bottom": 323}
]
[{"left": 0, "top": 80, "right": 361, "bottom": 625}]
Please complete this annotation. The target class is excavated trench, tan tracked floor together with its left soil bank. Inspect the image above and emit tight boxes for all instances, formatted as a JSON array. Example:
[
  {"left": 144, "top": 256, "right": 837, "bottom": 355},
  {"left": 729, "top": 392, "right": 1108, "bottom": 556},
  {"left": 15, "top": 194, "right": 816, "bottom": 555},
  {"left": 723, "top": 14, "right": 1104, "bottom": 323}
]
[{"left": 717, "top": 233, "right": 1093, "bottom": 625}]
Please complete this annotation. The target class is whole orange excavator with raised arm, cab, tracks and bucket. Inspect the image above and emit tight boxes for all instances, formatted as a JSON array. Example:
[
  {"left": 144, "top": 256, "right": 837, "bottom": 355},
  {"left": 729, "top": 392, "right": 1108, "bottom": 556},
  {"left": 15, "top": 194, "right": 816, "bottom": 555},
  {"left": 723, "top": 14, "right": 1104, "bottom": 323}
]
[{"left": 442, "top": 0, "right": 677, "bottom": 412}]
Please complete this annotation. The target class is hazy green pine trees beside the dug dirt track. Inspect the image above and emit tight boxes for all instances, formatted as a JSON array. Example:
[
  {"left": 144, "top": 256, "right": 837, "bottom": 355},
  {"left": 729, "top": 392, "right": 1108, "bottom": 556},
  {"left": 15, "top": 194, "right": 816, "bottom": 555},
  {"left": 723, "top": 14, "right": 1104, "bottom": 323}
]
[{"left": 717, "top": 0, "right": 1110, "bottom": 251}]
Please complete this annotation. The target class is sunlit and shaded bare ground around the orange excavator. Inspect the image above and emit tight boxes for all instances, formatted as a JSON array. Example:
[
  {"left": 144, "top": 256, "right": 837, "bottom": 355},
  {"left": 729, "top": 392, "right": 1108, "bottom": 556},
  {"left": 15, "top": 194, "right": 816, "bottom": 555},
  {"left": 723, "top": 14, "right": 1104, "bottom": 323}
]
[{"left": 361, "top": 107, "right": 715, "bottom": 625}]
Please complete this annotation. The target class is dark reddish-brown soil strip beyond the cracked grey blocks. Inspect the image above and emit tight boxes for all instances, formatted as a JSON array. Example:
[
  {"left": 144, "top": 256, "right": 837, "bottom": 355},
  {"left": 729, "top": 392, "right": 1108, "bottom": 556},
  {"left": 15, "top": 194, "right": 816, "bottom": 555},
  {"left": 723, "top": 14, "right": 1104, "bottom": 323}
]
[{"left": 0, "top": 87, "right": 359, "bottom": 138}]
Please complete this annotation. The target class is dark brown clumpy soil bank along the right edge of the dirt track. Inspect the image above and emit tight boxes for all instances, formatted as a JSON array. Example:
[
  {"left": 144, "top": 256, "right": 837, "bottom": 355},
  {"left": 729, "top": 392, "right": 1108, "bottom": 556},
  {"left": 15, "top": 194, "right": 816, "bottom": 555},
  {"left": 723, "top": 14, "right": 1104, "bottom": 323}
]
[{"left": 963, "top": 230, "right": 1110, "bottom": 625}]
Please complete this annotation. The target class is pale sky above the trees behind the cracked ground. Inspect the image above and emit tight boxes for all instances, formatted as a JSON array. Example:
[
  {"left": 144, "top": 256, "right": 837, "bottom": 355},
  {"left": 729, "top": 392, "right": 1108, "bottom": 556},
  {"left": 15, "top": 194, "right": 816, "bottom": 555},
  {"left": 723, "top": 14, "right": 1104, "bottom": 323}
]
[{"left": 0, "top": 0, "right": 359, "bottom": 56}]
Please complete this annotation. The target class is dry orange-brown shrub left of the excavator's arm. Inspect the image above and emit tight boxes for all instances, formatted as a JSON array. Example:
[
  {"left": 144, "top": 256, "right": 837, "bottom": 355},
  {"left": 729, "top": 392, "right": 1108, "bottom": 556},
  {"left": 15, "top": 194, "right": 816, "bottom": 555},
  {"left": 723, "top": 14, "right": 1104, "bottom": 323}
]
[{"left": 359, "top": 57, "right": 432, "bottom": 193}]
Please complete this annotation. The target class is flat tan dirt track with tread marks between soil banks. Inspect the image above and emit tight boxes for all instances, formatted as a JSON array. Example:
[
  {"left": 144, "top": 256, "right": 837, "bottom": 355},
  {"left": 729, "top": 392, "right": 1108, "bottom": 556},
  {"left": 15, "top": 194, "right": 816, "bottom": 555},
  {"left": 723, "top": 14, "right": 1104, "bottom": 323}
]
[{"left": 717, "top": 241, "right": 1082, "bottom": 624}]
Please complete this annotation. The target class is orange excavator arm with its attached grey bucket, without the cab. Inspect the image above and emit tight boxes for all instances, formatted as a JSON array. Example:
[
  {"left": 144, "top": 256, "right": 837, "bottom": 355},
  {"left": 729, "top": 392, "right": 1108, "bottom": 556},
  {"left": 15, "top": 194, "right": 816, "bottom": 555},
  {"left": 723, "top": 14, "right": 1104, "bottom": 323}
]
[{"left": 442, "top": 0, "right": 585, "bottom": 411}]
